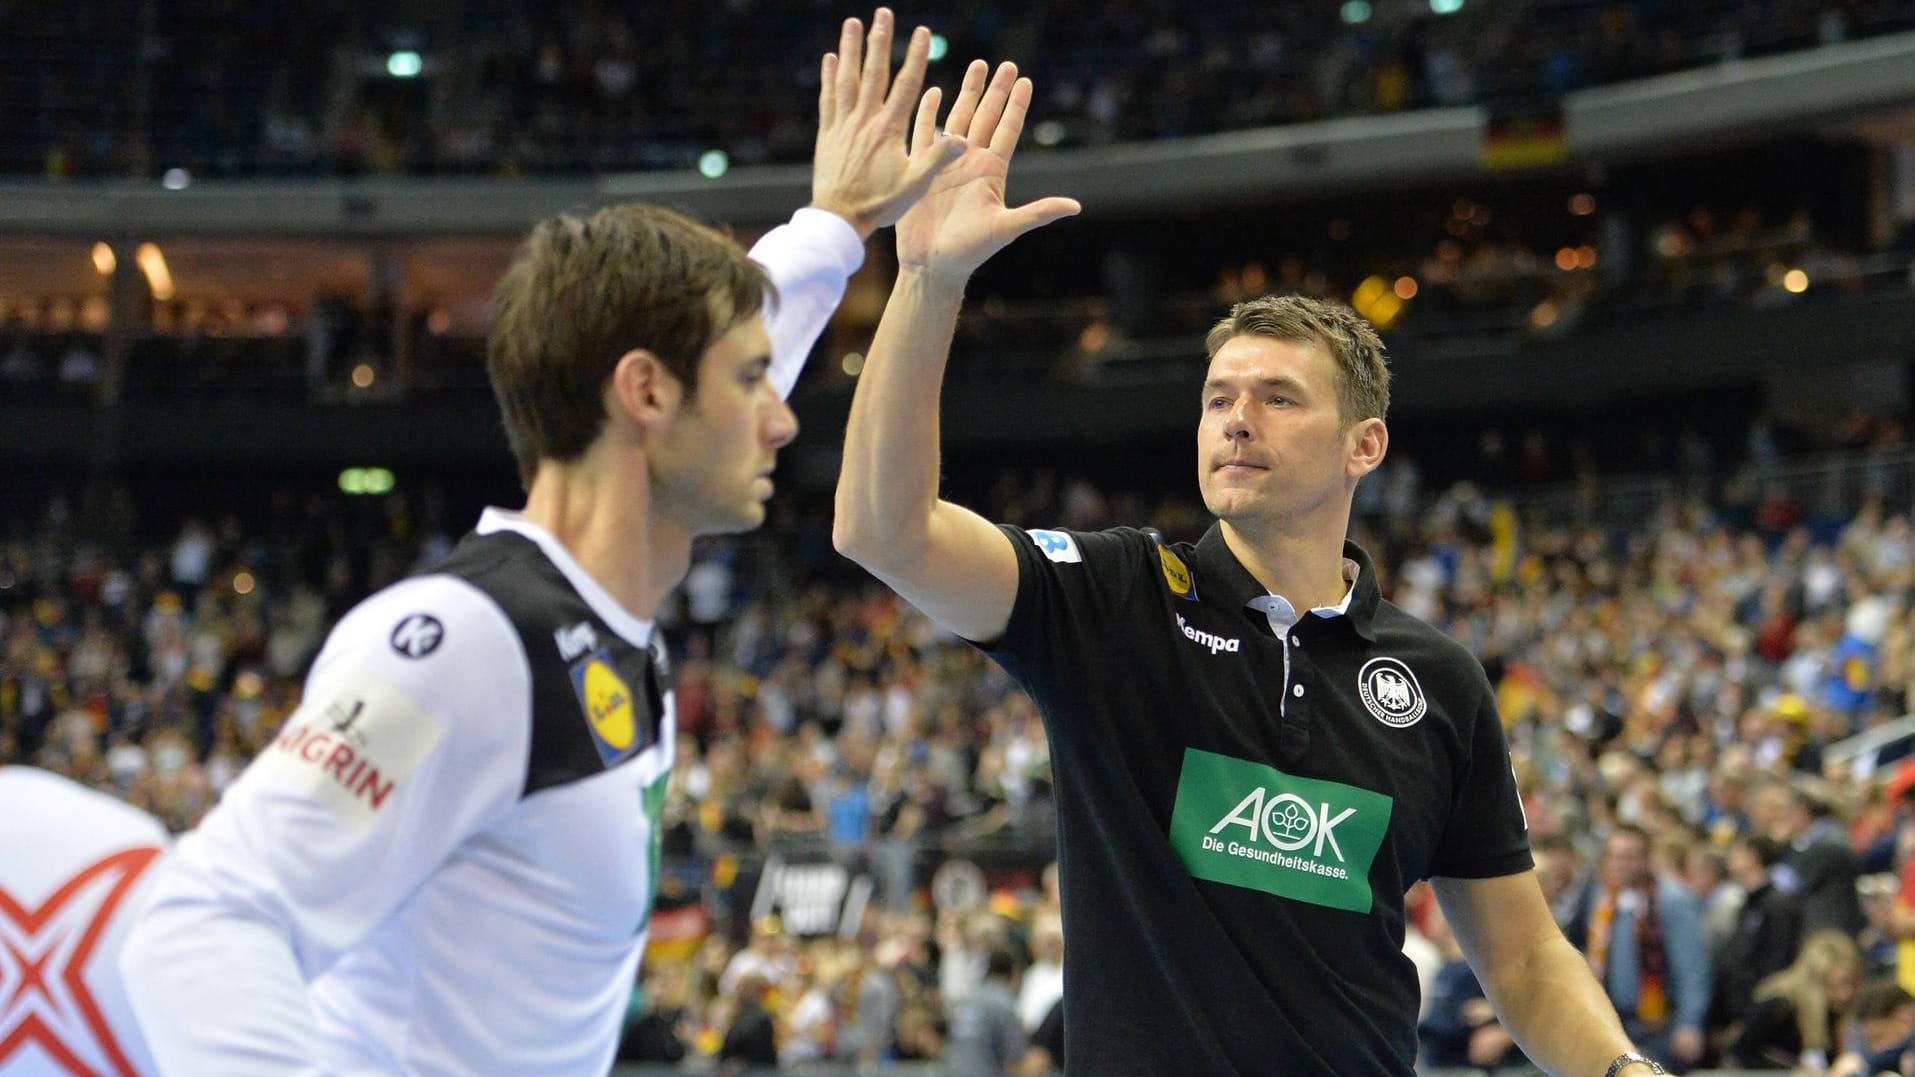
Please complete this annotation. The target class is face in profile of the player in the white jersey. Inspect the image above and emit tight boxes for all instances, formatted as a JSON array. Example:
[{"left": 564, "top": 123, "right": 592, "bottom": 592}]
[{"left": 655, "top": 316, "right": 799, "bottom": 535}]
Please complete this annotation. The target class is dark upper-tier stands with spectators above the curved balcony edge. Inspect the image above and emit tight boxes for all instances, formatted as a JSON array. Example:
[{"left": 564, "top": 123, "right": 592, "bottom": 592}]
[{"left": 0, "top": 0, "right": 1911, "bottom": 178}]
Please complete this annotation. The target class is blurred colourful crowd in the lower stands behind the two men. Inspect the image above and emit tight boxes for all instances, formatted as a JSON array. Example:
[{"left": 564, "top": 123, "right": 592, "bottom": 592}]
[{"left": 0, "top": 400, "right": 1915, "bottom": 1073}]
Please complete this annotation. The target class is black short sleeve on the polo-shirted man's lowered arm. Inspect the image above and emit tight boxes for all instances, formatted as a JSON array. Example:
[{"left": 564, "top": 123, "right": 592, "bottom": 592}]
[{"left": 1429, "top": 675, "right": 1534, "bottom": 880}]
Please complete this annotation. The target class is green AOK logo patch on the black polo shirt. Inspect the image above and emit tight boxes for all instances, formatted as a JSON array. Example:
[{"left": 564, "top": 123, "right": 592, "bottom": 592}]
[{"left": 1170, "top": 747, "right": 1394, "bottom": 912}]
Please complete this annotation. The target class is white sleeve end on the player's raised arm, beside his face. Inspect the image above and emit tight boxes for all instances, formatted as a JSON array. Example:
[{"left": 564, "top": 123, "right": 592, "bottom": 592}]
[{"left": 751, "top": 207, "right": 864, "bottom": 397}]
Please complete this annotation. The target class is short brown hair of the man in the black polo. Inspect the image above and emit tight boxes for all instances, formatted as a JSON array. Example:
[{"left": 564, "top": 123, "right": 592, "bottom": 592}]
[{"left": 1205, "top": 295, "right": 1390, "bottom": 425}]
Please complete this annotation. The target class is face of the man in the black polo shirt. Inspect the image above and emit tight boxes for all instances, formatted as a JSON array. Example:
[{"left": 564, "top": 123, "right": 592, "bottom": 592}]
[{"left": 1197, "top": 335, "right": 1388, "bottom": 525}]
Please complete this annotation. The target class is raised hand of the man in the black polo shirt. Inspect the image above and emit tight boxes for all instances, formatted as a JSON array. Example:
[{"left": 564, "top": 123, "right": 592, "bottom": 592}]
[{"left": 898, "top": 59, "right": 1082, "bottom": 278}]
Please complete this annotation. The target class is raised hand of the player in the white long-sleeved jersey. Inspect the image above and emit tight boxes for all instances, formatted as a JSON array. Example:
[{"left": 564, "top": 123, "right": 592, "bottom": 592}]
[{"left": 812, "top": 8, "right": 963, "bottom": 238}]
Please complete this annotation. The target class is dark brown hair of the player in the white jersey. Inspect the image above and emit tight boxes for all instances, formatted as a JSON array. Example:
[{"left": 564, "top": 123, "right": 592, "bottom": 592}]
[{"left": 486, "top": 203, "right": 772, "bottom": 489}]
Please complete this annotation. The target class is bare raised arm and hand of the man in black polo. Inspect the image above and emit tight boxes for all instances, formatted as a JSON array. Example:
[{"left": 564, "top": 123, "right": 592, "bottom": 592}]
[{"left": 831, "top": 59, "right": 1078, "bottom": 642}]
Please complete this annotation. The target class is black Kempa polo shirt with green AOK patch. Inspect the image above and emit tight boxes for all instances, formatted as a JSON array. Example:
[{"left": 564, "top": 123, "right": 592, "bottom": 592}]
[{"left": 986, "top": 527, "right": 1530, "bottom": 1077}]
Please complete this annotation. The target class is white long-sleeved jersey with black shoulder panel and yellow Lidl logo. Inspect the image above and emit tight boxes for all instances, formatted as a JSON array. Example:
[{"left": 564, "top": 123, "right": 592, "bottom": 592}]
[{"left": 124, "top": 211, "right": 864, "bottom": 1077}]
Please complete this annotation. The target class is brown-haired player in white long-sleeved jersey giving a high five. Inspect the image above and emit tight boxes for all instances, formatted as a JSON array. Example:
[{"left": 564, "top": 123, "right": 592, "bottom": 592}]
[{"left": 123, "top": 10, "right": 963, "bottom": 1077}]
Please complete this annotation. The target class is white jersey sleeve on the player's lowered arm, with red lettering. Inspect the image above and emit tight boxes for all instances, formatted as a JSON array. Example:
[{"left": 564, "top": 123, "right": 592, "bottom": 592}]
[{"left": 121, "top": 575, "right": 530, "bottom": 1077}]
